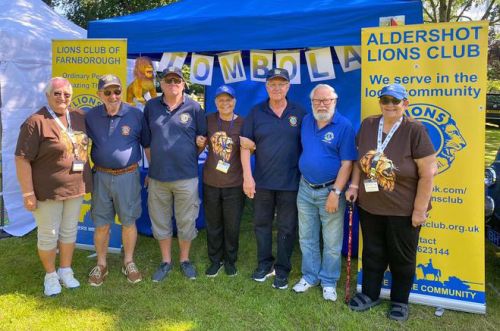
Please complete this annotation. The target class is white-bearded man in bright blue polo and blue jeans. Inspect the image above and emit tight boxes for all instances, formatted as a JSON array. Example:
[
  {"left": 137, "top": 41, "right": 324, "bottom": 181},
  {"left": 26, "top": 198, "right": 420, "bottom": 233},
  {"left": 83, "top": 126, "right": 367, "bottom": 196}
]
[{"left": 293, "top": 84, "right": 357, "bottom": 301}]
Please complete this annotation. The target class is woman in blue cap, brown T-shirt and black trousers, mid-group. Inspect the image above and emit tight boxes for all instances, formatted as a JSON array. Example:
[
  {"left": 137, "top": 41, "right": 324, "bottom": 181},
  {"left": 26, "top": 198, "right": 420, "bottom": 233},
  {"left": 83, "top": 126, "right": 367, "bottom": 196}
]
[{"left": 196, "top": 85, "right": 244, "bottom": 277}]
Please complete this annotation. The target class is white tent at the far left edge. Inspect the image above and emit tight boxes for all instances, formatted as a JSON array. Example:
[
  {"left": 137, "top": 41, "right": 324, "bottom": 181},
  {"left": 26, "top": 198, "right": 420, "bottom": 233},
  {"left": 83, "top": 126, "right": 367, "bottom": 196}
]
[{"left": 0, "top": 0, "right": 87, "bottom": 236}]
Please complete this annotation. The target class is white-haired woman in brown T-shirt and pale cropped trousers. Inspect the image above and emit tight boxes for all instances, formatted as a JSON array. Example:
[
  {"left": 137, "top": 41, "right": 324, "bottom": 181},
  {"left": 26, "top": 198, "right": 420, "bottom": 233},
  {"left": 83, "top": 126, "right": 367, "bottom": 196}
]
[{"left": 15, "top": 77, "right": 89, "bottom": 296}]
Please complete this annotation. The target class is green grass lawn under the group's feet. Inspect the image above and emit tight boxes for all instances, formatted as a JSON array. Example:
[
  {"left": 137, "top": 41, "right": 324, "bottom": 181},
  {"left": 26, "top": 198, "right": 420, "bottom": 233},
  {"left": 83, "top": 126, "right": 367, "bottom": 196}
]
[{"left": 0, "top": 129, "right": 500, "bottom": 331}]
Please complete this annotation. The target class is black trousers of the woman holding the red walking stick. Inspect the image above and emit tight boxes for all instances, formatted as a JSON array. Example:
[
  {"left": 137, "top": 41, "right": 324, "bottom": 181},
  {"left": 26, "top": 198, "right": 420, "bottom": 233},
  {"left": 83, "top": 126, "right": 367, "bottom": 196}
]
[{"left": 359, "top": 208, "right": 420, "bottom": 303}]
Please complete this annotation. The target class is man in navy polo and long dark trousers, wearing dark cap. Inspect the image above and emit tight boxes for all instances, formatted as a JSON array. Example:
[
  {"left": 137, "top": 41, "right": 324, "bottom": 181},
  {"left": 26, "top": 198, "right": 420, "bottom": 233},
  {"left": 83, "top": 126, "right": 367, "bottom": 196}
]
[{"left": 241, "top": 68, "right": 305, "bottom": 289}]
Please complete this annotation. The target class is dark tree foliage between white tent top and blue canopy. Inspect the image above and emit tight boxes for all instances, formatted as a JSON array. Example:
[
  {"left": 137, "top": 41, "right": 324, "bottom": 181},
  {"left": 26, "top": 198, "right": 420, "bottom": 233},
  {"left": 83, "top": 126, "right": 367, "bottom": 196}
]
[{"left": 43, "top": 0, "right": 177, "bottom": 29}]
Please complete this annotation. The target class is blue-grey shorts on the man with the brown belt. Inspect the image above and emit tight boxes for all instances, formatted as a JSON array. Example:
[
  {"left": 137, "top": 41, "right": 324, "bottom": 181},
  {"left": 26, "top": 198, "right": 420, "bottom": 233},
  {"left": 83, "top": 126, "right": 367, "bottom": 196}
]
[{"left": 91, "top": 169, "right": 142, "bottom": 227}]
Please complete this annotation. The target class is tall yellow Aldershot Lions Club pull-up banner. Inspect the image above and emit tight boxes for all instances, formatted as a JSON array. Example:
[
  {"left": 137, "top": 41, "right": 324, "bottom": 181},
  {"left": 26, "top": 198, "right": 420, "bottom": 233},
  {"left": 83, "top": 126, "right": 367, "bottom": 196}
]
[{"left": 358, "top": 22, "right": 488, "bottom": 313}]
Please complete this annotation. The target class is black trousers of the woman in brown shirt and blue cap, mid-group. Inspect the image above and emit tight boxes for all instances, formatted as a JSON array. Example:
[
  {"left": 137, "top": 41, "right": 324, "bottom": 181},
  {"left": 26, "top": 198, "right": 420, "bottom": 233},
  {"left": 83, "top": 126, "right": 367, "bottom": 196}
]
[{"left": 203, "top": 184, "right": 245, "bottom": 263}]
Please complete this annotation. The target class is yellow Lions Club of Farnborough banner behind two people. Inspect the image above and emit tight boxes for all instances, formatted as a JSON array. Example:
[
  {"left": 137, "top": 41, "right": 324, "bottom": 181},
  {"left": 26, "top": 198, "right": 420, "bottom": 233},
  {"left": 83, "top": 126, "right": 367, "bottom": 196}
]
[{"left": 52, "top": 39, "right": 127, "bottom": 252}]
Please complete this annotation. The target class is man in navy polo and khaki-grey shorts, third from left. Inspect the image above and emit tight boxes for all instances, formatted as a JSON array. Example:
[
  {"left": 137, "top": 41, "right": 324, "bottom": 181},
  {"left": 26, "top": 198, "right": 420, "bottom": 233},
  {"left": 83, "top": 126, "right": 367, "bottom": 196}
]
[{"left": 144, "top": 67, "right": 207, "bottom": 282}]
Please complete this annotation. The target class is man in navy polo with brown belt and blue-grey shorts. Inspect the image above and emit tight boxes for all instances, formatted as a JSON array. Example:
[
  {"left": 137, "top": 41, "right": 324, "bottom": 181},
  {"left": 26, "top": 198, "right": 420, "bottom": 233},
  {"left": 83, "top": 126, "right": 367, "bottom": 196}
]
[{"left": 85, "top": 75, "right": 149, "bottom": 286}]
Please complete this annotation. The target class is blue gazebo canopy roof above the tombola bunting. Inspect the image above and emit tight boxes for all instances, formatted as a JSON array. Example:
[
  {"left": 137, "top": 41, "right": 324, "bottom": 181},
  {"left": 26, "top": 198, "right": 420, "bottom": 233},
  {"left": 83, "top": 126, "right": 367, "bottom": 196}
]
[{"left": 88, "top": 0, "right": 422, "bottom": 58}]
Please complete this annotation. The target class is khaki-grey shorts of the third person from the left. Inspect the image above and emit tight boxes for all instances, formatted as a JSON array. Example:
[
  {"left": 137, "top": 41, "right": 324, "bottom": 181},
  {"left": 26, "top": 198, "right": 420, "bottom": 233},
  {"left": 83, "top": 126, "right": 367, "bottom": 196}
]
[{"left": 148, "top": 177, "right": 200, "bottom": 240}]
